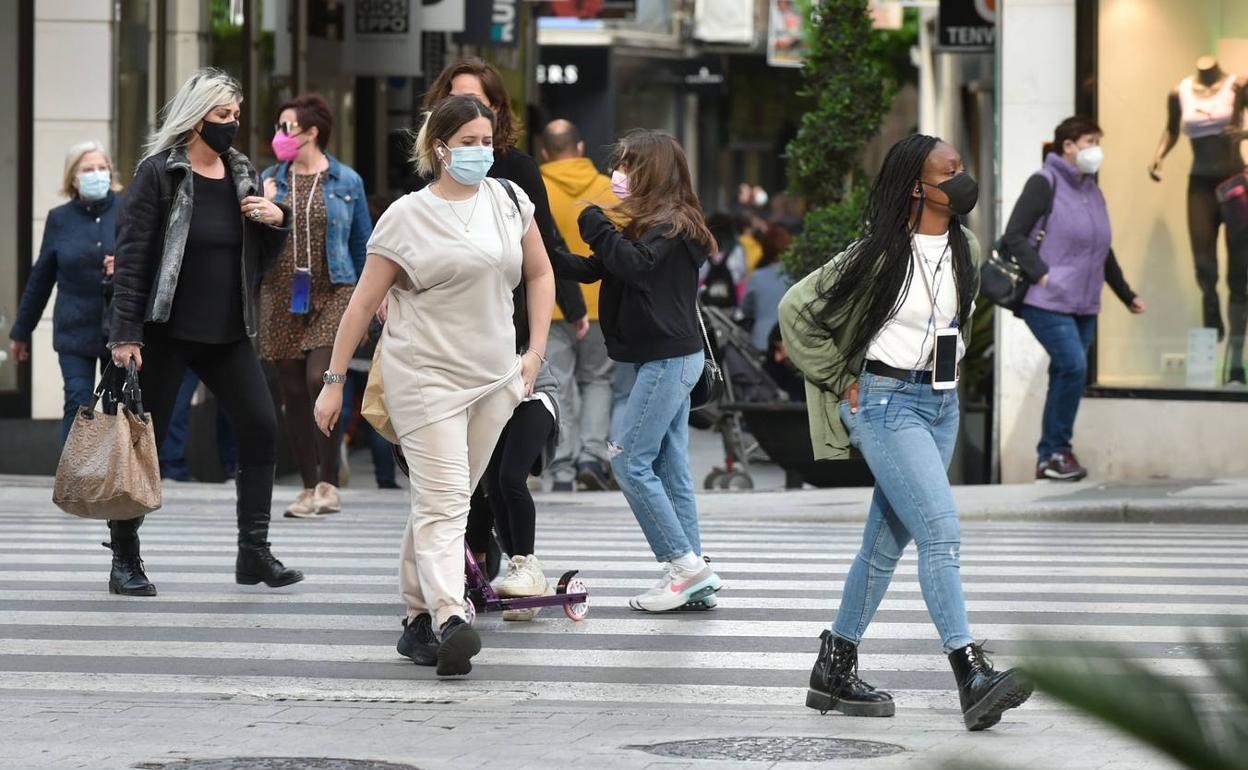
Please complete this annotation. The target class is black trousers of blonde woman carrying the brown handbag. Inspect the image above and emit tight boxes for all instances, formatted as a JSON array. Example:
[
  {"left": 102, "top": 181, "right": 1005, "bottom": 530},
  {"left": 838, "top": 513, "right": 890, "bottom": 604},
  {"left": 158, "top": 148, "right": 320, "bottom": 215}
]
[{"left": 110, "top": 327, "right": 277, "bottom": 538}]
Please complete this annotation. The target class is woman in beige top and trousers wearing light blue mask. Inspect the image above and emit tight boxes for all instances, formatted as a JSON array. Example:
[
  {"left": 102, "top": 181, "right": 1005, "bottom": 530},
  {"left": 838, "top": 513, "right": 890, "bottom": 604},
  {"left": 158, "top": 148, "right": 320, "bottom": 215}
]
[{"left": 316, "top": 96, "right": 554, "bottom": 676}]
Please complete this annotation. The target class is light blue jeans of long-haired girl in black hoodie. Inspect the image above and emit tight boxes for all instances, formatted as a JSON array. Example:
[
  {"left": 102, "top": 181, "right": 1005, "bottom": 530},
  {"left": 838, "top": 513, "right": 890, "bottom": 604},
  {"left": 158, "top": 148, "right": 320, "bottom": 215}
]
[{"left": 612, "top": 351, "right": 704, "bottom": 562}]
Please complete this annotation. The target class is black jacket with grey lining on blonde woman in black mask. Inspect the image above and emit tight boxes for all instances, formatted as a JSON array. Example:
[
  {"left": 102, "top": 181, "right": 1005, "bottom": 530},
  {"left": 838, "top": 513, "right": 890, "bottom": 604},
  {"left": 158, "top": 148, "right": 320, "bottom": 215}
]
[{"left": 109, "top": 146, "right": 291, "bottom": 347}]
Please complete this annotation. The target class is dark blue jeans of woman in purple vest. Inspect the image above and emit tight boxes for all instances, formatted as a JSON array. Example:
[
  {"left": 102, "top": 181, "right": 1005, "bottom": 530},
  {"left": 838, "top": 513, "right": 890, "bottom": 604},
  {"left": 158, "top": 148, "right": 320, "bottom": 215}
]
[{"left": 1021, "top": 305, "right": 1096, "bottom": 461}]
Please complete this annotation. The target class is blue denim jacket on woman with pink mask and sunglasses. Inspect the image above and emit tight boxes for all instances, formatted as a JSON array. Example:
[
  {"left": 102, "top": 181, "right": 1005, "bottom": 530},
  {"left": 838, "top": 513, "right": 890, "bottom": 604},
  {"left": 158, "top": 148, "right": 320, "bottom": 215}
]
[{"left": 260, "top": 152, "right": 373, "bottom": 283}]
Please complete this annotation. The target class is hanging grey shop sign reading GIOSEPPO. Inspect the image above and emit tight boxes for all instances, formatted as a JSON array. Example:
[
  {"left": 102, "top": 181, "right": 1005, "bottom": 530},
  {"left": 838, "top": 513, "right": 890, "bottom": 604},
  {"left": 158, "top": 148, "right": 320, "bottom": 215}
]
[{"left": 341, "top": 0, "right": 421, "bottom": 76}]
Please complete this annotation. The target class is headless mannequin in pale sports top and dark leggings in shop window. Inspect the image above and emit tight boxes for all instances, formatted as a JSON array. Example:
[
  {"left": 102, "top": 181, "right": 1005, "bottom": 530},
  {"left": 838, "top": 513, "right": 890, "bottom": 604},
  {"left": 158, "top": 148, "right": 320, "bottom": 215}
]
[{"left": 1148, "top": 56, "right": 1248, "bottom": 383}]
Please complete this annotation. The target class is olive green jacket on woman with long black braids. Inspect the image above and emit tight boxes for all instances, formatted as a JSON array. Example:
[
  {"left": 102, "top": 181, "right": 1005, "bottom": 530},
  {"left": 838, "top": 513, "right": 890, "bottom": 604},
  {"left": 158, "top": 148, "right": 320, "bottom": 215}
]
[{"left": 780, "top": 227, "right": 981, "bottom": 459}]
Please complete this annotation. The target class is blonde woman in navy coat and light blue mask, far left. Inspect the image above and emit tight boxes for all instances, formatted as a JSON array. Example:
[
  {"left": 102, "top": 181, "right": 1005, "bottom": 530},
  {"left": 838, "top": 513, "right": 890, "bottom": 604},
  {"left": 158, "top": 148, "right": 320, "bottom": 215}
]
[{"left": 9, "top": 141, "right": 122, "bottom": 441}]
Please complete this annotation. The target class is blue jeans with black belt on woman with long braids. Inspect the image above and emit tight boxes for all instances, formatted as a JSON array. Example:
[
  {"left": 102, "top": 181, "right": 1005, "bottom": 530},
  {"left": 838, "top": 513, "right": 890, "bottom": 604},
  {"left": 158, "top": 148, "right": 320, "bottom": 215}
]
[{"left": 832, "top": 373, "right": 973, "bottom": 651}]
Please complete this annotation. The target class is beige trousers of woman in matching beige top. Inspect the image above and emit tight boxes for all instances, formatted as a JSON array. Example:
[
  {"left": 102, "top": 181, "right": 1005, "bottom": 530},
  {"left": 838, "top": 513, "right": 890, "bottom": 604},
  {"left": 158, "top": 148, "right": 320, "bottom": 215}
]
[{"left": 398, "top": 374, "right": 524, "bottom": 630}]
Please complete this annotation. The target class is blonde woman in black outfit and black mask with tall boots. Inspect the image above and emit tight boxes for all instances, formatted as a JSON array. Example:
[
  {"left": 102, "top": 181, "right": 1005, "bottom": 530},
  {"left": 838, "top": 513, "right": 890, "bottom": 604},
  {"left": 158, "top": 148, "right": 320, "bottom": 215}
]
[{"left": 109, "top": 69, "right": 303, "bottom": 597}]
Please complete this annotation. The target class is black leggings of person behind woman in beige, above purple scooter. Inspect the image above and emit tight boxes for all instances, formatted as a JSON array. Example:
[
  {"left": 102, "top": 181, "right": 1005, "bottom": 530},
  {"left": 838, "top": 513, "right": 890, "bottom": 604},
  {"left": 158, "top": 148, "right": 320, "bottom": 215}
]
[{"left": 468, "top": 401, "right": 554, "bottom": 557}]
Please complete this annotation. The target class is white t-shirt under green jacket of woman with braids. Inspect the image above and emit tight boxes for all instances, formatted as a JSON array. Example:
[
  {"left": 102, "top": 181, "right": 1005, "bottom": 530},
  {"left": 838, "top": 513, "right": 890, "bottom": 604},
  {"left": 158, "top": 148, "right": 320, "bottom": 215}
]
[{"left": 866, "top": 232, "right": 963, "bottom": 371}]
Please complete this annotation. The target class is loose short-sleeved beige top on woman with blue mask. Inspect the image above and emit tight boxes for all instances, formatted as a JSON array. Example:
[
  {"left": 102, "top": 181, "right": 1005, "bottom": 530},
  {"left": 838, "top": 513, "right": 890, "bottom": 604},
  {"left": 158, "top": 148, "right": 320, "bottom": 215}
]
[{"left": 368, "top": 180, "right": 533, "bottom": 437}]
